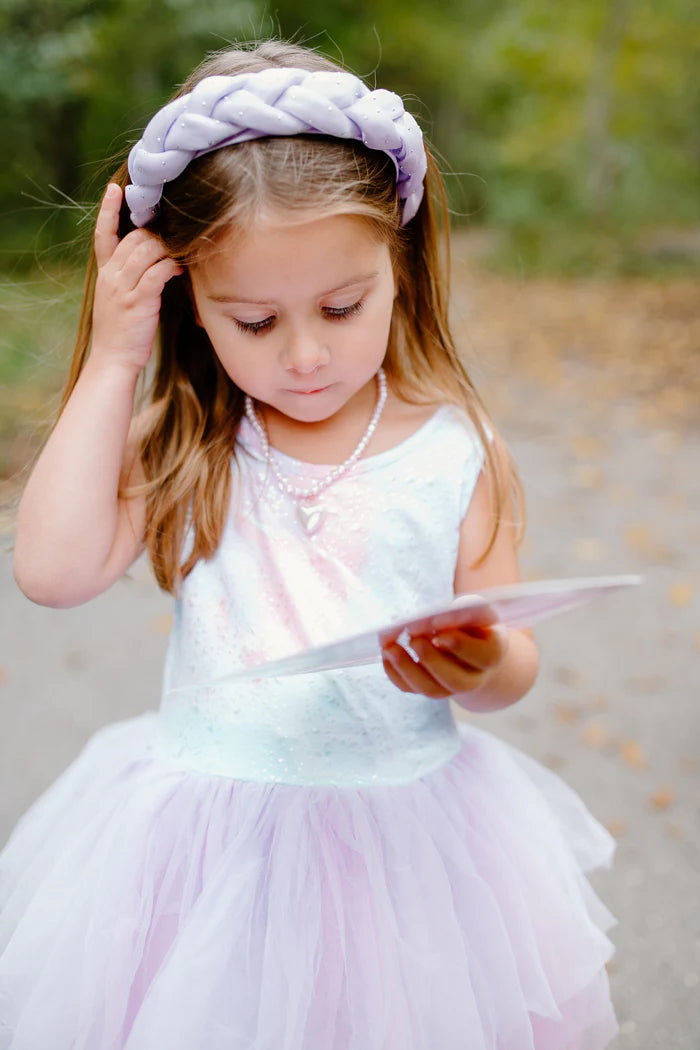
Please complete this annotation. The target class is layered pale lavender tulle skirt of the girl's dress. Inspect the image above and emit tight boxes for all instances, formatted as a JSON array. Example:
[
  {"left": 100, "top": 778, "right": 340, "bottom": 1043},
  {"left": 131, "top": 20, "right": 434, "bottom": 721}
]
[{"left": 0, "top": 713, "right": 616, "bottom": 1050}]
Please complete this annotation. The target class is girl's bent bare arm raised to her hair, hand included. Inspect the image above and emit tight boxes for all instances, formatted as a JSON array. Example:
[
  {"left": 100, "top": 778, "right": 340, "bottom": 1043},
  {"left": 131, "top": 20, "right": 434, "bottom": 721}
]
[{"left": 15, "top": 185, "right": 181, "bottom": 607}]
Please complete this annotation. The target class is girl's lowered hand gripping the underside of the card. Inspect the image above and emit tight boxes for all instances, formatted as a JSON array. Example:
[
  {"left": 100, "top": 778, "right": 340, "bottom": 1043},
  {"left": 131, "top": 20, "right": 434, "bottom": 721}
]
[{"left": 382, "top": 624, "right": 509, "bottom": 699}]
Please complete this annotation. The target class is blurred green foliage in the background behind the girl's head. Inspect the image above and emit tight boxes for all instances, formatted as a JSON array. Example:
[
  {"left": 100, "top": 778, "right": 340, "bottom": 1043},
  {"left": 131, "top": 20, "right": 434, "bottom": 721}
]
[{"left": 0, "top": 0, "right": 700, "bottom": 272}]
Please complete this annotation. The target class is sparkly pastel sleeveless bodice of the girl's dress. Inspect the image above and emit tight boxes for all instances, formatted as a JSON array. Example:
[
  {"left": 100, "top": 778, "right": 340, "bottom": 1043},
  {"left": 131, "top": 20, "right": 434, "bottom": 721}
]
[{"left": 155, "top": 405, "right": 483, "bottom": 785}]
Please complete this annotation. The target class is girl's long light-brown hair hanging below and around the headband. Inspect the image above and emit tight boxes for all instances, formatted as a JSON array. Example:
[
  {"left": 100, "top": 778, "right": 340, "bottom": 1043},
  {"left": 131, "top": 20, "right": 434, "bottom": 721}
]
[{"left": 62, "top": 41, "right": 523, "bottom": 592}]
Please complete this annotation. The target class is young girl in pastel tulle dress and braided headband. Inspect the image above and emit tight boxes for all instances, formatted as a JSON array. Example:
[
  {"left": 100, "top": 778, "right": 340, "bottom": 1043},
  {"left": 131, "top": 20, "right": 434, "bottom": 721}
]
[{"left": 0, "top": 43, "right": 615, "bottom": 1050}]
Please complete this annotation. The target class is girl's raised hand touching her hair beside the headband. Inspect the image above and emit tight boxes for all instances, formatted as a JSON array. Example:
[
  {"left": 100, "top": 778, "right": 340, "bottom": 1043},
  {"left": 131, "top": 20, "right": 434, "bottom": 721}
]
[{"left": 91, "top": 183, "right": 183, "bottom": 373}]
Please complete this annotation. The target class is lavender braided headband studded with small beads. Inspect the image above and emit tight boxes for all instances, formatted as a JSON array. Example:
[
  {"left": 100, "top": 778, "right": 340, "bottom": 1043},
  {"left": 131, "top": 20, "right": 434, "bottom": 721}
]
[{"left": 126, "top": 68, "right": 427, "bottom": 226}]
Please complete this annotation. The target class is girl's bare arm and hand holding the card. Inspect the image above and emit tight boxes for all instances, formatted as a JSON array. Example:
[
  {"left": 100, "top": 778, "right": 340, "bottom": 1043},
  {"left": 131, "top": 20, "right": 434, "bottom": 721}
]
[{"left": 384, "top": 473, "right": 538, "bottom": 711}]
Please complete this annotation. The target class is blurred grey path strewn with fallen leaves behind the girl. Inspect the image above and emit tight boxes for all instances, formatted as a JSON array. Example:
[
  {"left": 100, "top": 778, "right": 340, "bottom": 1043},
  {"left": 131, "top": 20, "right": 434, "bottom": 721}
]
[{"left": 0, "top": 240, "right": 700, "bottom": 1050}]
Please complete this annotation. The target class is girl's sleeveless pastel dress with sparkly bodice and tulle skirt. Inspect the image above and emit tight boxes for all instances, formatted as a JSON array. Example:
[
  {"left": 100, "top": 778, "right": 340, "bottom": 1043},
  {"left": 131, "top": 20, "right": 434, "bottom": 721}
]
[{"left": 0, "top": 406, "right": 616, "bottom": 1050}]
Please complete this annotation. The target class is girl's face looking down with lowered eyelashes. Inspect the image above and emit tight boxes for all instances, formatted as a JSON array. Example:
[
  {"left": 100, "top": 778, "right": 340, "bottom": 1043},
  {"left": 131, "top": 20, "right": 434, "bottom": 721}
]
[{"left": 190, "top": 215, "right": 396, "bottom": 423}]
